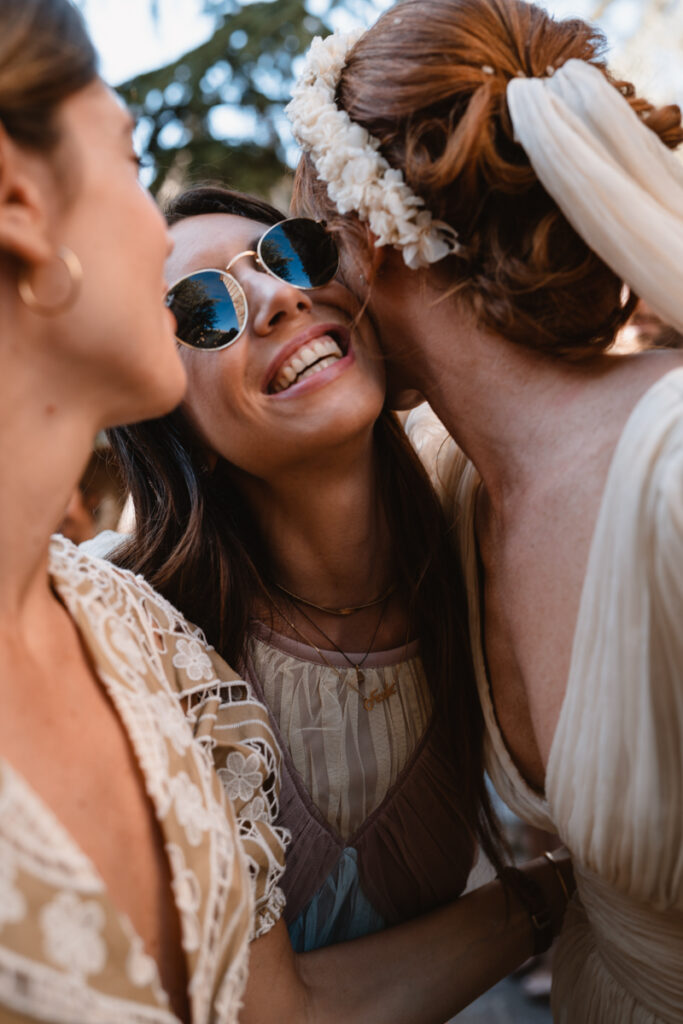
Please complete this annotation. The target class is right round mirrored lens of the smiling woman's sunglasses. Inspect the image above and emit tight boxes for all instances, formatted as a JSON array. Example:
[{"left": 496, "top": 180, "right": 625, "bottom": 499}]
[{"left": 259, "top": 217, "right": 339, "bottom": 288}]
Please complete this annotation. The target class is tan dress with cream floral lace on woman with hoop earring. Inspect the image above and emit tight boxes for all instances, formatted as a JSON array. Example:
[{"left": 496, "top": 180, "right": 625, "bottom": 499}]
[{"left": 0, "top": 538, "right": 284, "bottom": 1024}]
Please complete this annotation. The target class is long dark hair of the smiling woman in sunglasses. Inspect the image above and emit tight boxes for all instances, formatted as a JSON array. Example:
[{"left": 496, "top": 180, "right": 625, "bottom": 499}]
[{"left": 105, "top": 186, "right": 501, "bottom": 864}]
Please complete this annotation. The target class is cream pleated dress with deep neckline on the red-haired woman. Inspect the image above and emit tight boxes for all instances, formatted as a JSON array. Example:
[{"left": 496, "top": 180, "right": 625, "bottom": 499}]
[{"left": 409, "top": 369, "right": 683, "bottom": 1024}]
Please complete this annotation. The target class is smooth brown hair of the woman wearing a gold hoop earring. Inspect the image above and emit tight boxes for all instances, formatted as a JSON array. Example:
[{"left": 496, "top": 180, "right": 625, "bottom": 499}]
[{"left": 0, "top": 0, "right": 97, "bottom": 152}]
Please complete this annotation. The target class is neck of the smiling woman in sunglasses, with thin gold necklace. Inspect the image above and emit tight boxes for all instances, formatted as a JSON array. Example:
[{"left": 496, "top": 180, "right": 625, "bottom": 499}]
[{"left": 235, "top": 433, "right": 411, "bottom": 651}]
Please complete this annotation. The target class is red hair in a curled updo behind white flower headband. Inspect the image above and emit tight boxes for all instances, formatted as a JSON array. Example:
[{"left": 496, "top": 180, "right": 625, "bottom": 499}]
[{"left": 294, "top": 0, "right": 683, "bottom": 359}]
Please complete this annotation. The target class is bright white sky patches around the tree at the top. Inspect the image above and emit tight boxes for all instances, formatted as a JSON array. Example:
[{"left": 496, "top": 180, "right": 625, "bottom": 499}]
[{"left": 80, "top": 0, "right": 683, "bottom": 102}]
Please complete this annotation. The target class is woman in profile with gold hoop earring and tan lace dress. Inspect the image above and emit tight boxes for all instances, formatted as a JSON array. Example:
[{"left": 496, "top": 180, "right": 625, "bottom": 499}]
[{"left": 0, "top": 0, "right": 294, "bottom": 1024}]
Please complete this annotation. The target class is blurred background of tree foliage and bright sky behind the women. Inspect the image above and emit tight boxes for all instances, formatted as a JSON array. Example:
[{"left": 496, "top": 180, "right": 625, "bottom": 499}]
[{"left": 80, "top": 0, "right": 683, "bottom": 206}]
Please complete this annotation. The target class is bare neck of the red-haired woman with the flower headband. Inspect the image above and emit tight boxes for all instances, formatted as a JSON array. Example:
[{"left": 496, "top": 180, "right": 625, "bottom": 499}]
[{"left": 393, "top": 299, "right": 616, "bottom": 508}]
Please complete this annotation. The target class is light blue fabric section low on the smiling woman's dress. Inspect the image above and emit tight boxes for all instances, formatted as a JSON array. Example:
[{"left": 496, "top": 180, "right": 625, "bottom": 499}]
[{"left": 289, "top": 847, "right": 386, "bottom": 953}]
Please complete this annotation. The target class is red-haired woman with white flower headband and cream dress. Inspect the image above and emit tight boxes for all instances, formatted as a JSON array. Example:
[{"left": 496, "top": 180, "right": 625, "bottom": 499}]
[{"left": 290, "top": 0, "right": 683, "bottom": 1024}]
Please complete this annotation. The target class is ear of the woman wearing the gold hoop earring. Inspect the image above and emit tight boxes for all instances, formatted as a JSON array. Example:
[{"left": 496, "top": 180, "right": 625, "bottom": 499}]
[{"left": 0, "top": 124, "right": 54, "bottom": 265}]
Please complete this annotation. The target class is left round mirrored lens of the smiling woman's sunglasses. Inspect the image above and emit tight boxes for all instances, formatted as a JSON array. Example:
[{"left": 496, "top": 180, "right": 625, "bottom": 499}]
[{"left": 166, "top": 270, "right": 246, "bottom": 348}]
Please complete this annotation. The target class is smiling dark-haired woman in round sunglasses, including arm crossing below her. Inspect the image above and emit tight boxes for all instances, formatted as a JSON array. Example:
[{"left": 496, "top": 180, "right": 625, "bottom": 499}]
[{"left": 97, "top": 187, "right": 564, "bottom": 1022}]
